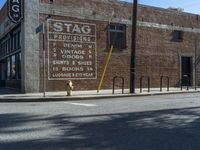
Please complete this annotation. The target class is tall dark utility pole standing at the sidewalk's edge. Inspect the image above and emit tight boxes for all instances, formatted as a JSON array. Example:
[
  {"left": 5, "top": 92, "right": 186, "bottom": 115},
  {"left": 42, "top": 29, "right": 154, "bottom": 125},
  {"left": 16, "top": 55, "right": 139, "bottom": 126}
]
[{"left": 130, "top": 0, "right": 138, "bottom": 93}]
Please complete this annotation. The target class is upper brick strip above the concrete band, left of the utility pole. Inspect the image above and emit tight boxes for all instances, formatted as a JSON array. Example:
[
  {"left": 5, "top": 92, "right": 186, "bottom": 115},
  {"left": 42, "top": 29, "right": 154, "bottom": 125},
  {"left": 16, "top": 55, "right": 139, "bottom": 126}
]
[{"left": 40, "top": 0, "right": 132, "bottom": 19}]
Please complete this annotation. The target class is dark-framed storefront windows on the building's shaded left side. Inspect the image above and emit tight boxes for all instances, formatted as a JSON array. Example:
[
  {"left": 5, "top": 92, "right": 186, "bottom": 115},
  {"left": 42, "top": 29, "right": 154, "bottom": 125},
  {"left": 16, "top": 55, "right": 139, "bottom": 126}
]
[{"left": 0, "top": 27, "right": 21, "bottom": 89}]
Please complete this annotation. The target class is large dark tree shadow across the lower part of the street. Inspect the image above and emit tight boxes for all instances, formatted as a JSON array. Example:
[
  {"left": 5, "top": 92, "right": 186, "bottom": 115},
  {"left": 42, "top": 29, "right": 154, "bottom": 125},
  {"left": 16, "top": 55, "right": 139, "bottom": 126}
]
[{"left": 0, "top": 107, "right": 200, "bottom": 150}]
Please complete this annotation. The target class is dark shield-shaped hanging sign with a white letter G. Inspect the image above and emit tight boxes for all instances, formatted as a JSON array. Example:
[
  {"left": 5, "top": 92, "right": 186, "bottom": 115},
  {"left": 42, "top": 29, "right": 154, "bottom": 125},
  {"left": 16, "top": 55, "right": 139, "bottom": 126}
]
[{"left": 8, "top": 0, "right": 23, "bottom": 23}]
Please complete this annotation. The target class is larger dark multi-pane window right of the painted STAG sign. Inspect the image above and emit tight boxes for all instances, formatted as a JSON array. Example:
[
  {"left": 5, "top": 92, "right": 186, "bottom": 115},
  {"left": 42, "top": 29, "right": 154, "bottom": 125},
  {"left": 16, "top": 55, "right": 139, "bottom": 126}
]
[{"left": 109, "top": 24, "right": 126, "bottom": 49}]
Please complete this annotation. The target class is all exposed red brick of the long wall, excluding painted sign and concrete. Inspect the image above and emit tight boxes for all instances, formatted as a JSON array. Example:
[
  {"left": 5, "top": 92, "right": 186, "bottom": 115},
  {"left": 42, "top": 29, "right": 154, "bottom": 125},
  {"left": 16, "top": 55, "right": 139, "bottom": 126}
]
[{"left": 40, "top": 0, "right": 200, "bottom": 91}]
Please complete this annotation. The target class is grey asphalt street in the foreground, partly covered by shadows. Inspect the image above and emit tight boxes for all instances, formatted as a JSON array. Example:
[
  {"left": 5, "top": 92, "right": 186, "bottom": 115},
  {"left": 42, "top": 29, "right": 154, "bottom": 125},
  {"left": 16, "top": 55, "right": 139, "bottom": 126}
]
[{"left": 0, "top": 93, "right": 200, "bottom": 150}]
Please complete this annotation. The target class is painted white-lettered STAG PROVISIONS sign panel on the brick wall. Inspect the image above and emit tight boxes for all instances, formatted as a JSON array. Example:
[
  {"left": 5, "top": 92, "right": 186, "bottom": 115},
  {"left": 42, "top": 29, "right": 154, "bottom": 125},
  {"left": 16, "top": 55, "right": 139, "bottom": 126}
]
[{"left": 47, "top": 19, "right": 97, "bottom": 80}]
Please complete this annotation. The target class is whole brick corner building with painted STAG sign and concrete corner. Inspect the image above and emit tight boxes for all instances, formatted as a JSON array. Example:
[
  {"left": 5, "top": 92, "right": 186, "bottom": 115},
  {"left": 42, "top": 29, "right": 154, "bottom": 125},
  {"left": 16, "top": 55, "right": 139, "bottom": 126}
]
[{"left": 0, "top": 0, "right": 200, "bottom": 92}]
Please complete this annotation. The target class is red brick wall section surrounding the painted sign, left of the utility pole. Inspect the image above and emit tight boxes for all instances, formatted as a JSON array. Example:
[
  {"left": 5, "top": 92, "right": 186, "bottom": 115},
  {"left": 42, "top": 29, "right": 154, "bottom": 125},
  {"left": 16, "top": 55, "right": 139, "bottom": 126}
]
[{"left": 40, "top": 15, "right": 131, "bottom": 91}]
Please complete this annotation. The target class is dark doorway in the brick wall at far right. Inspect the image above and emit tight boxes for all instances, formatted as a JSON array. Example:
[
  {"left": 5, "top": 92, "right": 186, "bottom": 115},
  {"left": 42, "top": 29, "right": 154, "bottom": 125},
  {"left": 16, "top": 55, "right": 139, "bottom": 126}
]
[{"left": 181, "top": 57, "right": 192, "bottom": 86}]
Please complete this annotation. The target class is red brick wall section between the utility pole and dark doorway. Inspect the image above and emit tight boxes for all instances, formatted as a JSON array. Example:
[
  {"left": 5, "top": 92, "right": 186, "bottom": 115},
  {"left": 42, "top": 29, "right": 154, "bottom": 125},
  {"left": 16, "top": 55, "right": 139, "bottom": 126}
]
[{"left": 136, "top": 28, "right": 200, "bottom": 87}]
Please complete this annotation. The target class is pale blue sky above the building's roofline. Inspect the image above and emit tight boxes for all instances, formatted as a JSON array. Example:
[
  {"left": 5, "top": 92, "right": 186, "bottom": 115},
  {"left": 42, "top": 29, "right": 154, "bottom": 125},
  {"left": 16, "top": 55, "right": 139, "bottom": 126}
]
[{"left": 0, "top": 0, "right": 200, "bottom": 14}]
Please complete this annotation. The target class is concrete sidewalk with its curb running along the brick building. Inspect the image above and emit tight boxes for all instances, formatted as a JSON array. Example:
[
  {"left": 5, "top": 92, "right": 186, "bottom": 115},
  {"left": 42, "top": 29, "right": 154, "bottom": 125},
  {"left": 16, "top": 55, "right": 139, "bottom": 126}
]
[{"left": 0, "top": 88, "right": 200, "bottom": 102}]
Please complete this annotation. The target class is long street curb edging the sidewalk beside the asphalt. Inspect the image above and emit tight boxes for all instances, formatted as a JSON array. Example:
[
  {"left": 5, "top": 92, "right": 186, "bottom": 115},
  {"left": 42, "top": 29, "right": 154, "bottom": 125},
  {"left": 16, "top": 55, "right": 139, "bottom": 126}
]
[{"left": 0, "top": 91, "right": 200, "bottom": 103}]
